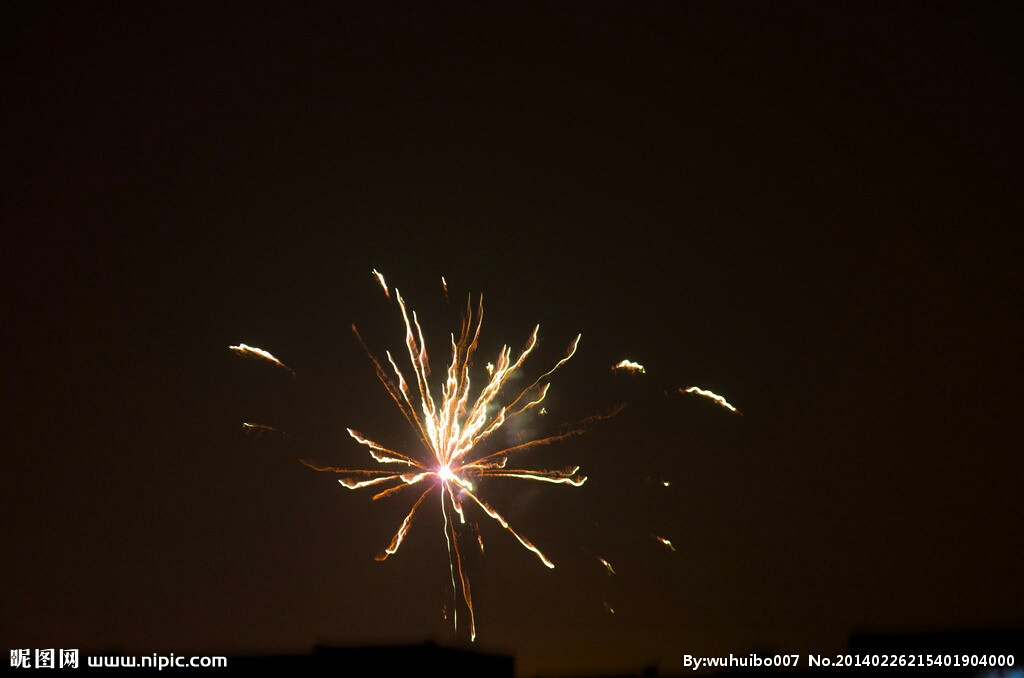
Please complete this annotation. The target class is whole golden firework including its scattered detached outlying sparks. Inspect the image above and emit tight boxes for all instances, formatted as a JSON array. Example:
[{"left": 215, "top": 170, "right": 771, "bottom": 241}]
[{"left": 229, "top": 270, "right": 739, "bottom": 639}]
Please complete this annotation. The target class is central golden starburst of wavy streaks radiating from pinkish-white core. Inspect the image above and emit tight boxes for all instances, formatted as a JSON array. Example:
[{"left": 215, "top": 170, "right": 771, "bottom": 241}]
[{"left": 311, "top": 270, "right": 598, "bottom": 639}]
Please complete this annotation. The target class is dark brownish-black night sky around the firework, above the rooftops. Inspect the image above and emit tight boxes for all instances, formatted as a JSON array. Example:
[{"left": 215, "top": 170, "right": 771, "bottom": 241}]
[{"left": 0, "top": 2, "right": 1024, "bottom": 675}]
